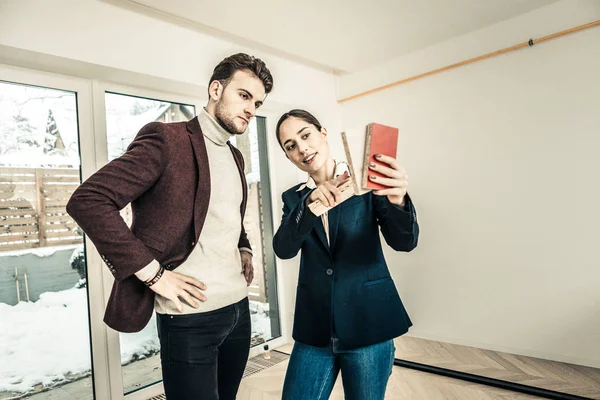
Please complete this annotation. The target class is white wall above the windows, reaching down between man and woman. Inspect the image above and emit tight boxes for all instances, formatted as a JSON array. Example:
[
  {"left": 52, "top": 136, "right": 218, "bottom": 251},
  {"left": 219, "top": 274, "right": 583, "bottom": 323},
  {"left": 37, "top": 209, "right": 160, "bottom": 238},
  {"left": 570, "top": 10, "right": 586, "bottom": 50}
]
[{"left": 0, "top": 0, "right": 341, "bottom": 344}]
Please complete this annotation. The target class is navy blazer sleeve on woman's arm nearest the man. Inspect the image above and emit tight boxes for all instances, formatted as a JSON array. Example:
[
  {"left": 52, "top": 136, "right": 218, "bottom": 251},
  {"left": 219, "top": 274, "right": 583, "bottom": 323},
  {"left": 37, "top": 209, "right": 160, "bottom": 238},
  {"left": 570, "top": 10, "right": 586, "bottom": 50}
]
[{"left": 273, "top": 191, "right": 319, "bottom": 260}]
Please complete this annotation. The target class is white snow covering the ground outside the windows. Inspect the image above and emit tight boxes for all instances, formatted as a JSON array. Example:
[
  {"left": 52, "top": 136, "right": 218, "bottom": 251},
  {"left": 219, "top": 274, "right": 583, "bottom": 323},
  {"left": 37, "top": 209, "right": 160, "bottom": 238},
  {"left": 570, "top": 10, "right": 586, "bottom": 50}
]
[{"left": 0, "top": 289, "right": 271, "bottom": 393}]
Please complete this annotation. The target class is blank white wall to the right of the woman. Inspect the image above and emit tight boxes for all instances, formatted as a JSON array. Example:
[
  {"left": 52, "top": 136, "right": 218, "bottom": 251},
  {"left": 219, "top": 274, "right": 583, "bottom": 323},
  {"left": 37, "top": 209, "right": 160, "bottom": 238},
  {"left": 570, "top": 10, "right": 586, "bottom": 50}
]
[{"left": 339, "top": 0, "right": 600, "bottom": 367}]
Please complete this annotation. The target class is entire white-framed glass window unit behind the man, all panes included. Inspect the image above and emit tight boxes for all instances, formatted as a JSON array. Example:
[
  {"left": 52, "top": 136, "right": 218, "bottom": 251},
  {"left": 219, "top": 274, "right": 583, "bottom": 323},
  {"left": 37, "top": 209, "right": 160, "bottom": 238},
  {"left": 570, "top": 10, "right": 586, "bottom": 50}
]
[{"left": 0, "top": 66, "right": 281, "bottom": 400}]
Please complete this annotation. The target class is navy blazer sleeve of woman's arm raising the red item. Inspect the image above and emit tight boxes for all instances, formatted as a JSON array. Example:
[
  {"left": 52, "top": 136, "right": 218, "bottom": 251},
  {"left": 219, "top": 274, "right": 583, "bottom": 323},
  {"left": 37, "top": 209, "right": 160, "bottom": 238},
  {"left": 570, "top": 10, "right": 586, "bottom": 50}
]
[{"left": 371, "top": 194, "right": 419, "bottom": 251}]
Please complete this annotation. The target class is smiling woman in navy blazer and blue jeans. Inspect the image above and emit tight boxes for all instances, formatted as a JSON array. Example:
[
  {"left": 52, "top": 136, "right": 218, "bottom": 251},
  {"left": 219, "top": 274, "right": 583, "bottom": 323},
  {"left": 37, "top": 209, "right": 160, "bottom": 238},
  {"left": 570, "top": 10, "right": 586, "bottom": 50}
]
[{"left": 273, "top": 110, "right": 419, "bottom": 400}]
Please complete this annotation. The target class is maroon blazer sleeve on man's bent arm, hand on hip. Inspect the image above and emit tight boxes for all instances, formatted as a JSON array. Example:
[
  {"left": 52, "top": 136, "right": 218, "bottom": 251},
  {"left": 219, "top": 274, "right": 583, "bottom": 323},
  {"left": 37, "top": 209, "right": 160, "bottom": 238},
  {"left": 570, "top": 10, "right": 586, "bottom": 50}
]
[{"left": 67, "top": 122, "right": 168, "bottom": 281}]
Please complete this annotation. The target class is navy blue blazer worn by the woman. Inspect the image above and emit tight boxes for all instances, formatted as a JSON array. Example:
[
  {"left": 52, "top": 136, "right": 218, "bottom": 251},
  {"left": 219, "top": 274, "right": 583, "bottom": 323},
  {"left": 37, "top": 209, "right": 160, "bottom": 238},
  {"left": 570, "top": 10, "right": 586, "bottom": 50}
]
[{"left": 273, "top": 185, "right": 419, "bottom": 348}]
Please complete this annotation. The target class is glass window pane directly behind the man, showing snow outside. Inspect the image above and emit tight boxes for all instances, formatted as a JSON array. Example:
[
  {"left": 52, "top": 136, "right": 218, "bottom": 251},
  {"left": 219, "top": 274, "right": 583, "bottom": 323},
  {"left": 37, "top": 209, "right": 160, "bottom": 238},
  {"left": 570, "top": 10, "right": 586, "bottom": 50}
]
[{"left": 105, "top": 92, "right": 280, "bottom": 394}]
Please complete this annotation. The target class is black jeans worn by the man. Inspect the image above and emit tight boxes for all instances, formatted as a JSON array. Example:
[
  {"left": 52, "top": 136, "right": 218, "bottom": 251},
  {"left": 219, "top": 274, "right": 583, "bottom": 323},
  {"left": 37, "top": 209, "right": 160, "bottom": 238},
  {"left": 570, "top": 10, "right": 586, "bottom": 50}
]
[{"left": 156, "top": 297, "right": 251, "bottom": 400}]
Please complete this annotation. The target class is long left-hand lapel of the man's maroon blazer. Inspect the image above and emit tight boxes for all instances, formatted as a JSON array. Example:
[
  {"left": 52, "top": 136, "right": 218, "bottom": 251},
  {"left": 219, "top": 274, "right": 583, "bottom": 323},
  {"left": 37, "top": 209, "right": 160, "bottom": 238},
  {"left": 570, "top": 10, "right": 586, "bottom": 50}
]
[{"left": 187, "top": 117, "right": 210, "bottom": 240}]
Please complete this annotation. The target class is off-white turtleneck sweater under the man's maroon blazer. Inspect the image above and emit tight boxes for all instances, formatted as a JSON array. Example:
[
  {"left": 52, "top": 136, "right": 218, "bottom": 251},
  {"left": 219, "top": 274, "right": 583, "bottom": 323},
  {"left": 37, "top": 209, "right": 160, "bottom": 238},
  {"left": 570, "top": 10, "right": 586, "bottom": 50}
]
[{"left": 136, "top": 109, "right": 249, "bottom": 314}]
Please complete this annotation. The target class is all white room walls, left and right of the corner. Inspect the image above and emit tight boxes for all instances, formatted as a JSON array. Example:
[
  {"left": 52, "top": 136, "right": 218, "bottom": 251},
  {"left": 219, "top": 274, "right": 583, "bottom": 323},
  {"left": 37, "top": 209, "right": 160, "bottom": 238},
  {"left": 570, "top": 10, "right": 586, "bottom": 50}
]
[{"left": 0, "top": 0, "right": 600, "bottom": 366}]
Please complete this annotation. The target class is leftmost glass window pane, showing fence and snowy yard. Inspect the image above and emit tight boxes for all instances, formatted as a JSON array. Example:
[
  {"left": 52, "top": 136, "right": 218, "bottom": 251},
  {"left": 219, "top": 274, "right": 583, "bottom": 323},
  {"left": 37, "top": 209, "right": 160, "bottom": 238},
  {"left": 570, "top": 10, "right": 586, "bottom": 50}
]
[{"left": 0, "top": 82, "right": 93, "bottom": 399}]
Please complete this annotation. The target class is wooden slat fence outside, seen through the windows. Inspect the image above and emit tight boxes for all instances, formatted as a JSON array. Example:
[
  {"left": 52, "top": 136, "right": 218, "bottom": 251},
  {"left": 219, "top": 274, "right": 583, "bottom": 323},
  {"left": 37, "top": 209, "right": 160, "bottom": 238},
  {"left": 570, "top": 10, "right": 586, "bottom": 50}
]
[{"left": 0, "top": 167, "right": 267, "bottom": 303}]
